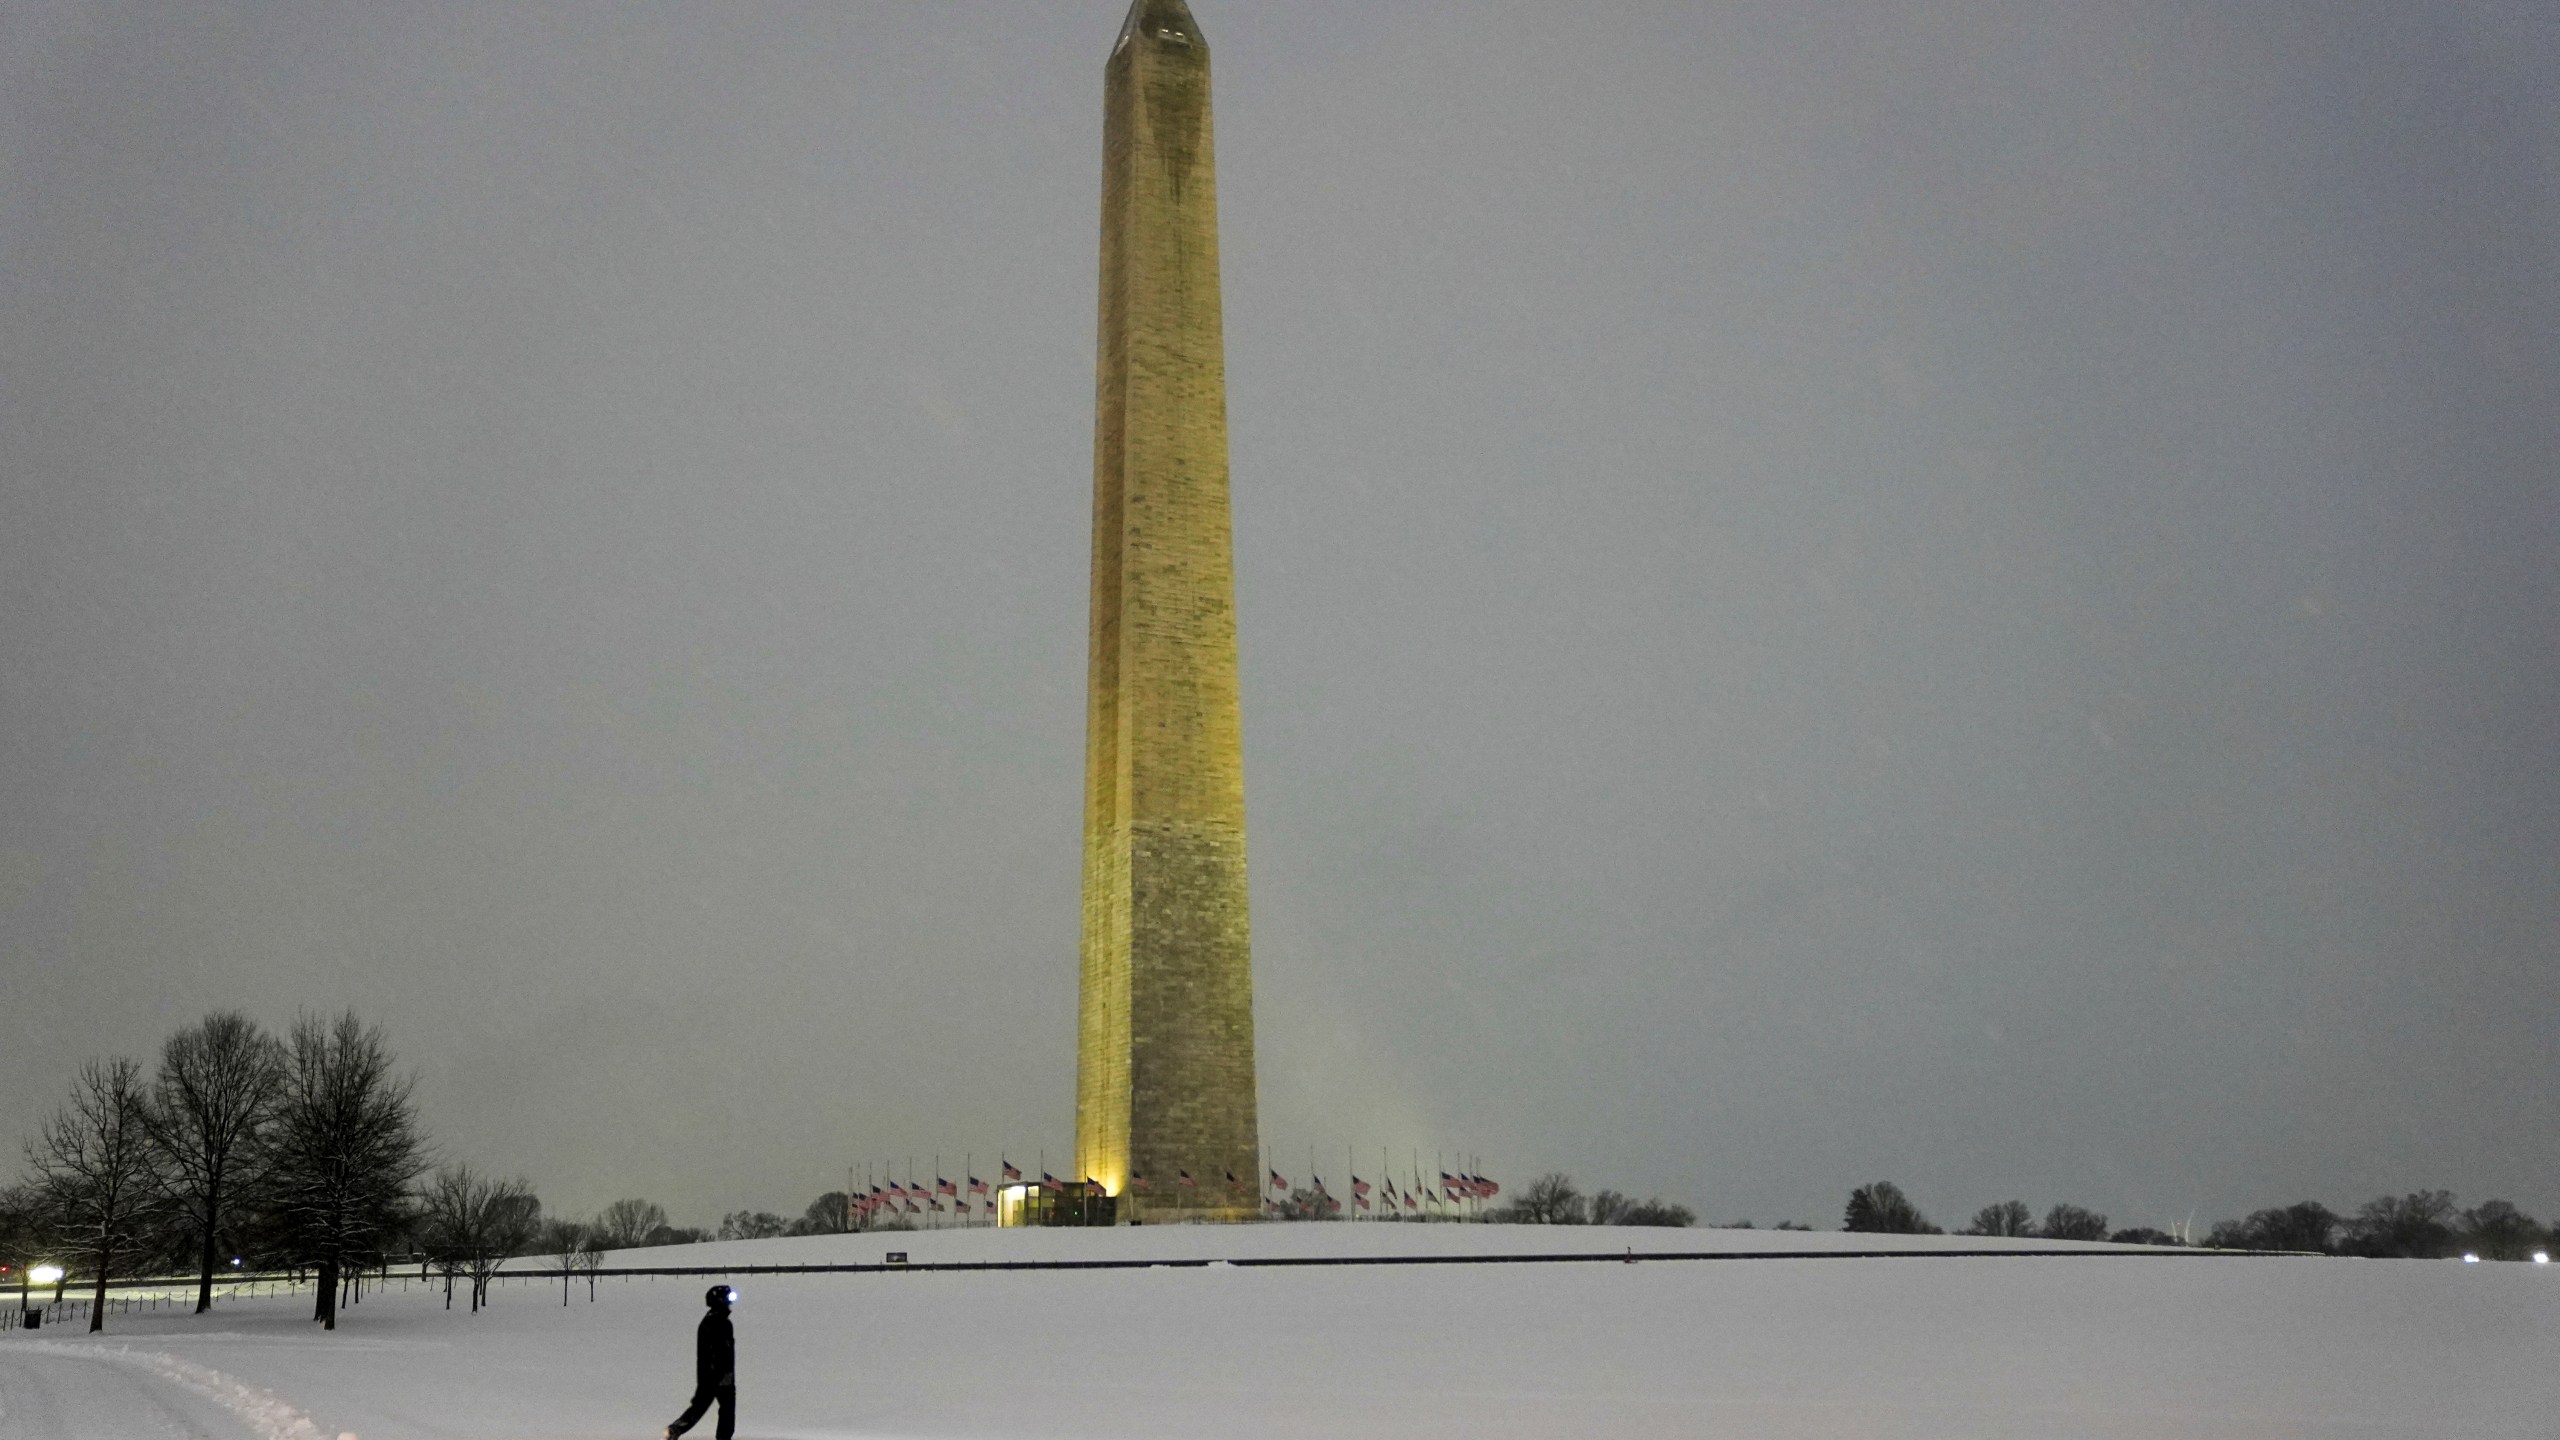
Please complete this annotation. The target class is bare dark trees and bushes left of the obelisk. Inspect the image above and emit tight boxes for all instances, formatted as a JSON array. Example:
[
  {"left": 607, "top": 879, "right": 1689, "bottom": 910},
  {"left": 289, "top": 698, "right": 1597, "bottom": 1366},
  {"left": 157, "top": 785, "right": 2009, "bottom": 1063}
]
[{"left": 0, "top": 1012, "right": 847, "bottom": 1330}]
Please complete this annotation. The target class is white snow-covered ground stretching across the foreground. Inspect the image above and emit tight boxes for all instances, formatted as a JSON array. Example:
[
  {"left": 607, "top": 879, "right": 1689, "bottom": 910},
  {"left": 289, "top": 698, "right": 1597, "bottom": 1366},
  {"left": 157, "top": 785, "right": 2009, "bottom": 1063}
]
[{"left": 0, "top": 1225, "right": 2560, "bottom": 1440}]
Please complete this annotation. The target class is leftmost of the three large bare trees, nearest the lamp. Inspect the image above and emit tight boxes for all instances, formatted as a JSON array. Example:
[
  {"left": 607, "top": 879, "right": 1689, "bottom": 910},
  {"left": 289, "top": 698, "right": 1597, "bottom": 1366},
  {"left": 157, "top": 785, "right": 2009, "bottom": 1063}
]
[{"left": 26, "top": 1058, "right": 161, "bottom": 1330}]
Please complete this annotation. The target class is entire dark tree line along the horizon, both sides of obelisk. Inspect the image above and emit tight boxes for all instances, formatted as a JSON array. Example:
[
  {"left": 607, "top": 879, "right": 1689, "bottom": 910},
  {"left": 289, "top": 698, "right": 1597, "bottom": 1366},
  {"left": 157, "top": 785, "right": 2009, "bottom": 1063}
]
[{"left": 20, "top": 1012, "right": 2560, "bottom": 1330}]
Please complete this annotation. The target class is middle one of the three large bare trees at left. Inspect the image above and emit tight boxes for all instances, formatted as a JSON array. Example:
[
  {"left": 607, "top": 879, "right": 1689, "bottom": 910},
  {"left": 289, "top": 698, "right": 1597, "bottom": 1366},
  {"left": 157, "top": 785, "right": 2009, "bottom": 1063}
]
[{"left": 143, "top": 1010, "right": 284, "bottom": 1314}]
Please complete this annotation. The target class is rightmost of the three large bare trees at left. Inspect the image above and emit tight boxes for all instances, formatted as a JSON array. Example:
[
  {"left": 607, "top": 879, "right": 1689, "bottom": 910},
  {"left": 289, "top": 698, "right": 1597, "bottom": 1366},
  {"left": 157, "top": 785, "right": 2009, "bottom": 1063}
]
[{"left": 269, "top": 1010, "right": 425, "bottom": 1330}]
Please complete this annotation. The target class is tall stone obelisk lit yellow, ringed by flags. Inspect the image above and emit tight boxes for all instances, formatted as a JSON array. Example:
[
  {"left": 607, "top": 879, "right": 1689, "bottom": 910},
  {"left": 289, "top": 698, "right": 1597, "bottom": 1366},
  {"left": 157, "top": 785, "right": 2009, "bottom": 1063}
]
[{"left": 1075, "top": 0, "right": 1262, "bottom": 1222}]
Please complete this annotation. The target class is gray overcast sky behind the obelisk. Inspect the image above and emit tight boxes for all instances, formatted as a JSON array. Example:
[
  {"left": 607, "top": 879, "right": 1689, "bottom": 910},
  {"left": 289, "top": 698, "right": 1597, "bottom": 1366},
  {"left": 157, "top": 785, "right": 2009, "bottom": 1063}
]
[{"left": 0, "top": 0, "right": 2560, "bottom": 1225}]
